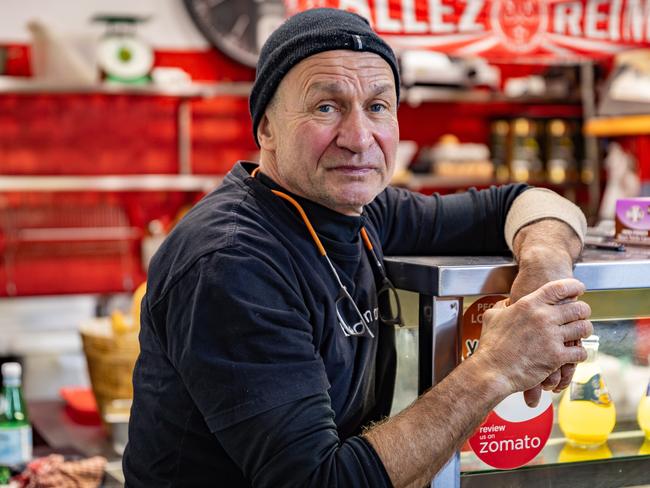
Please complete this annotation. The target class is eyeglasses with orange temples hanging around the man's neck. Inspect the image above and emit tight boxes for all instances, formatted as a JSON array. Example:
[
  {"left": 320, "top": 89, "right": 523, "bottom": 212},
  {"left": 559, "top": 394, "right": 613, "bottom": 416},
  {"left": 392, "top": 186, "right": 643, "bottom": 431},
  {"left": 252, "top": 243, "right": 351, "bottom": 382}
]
[{"left": 260, "top": 181, "right": 403, "bottom": 337}]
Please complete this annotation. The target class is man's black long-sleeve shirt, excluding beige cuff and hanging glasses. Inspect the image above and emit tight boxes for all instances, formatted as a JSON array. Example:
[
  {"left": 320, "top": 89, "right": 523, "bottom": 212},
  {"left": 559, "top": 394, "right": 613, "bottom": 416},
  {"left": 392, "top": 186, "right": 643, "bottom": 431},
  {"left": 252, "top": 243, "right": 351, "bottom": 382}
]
[{"left": 124, "top": 163, "right": 526, "bottom": 487}]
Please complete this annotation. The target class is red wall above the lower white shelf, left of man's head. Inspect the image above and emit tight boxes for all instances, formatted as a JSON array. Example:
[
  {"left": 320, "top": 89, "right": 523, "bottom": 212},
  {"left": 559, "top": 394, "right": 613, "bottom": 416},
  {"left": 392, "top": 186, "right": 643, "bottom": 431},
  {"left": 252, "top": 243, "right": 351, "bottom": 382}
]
[{"left": 0, "top": 46, "right": 256, "bottom": 174}]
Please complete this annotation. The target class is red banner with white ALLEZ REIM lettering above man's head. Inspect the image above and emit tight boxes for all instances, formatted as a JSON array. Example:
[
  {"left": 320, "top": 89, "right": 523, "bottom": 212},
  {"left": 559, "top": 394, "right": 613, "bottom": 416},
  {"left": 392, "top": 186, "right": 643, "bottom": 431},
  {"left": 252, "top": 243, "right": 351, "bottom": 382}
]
[{"left": 285, "top": 0, "right": 650, "bottom": 60}]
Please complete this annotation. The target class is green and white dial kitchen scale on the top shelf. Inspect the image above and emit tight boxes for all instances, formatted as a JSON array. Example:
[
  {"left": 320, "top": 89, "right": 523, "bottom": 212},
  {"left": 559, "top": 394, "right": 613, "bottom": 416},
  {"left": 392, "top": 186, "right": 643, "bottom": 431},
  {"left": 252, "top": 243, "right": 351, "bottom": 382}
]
[{"left": 92, "top": 14, "right": 154, "bottom": 85}]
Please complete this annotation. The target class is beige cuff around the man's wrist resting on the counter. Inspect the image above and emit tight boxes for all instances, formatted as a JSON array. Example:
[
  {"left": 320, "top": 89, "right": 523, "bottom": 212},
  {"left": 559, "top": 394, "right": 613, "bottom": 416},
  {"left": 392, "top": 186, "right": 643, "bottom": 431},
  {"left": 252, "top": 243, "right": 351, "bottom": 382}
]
[{"left": 505, "top": 188, "right": 587, "bottom": 251}]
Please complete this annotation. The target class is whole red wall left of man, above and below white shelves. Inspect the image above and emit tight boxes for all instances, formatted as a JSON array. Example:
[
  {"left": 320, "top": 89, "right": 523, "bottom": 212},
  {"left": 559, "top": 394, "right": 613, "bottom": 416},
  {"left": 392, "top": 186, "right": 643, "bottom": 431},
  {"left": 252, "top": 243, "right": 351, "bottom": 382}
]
[{"left": 0, "top": 46, "right": 256, "bottom": 296}]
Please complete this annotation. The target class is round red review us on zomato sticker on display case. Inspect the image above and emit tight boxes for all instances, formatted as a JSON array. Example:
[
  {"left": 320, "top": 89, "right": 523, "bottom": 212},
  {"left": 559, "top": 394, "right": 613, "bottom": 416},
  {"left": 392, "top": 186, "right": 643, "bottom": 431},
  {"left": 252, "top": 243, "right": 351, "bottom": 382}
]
[{"left": 469, "top": 391, "right": 553, "bottom": 469}]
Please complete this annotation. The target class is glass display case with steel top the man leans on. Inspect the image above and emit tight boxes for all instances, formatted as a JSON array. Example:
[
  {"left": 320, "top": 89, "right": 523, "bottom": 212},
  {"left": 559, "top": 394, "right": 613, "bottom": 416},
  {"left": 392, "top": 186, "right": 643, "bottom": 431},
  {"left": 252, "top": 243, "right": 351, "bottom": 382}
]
[{"left": 386, "top": 248, "right": 650, "bottom": 487}]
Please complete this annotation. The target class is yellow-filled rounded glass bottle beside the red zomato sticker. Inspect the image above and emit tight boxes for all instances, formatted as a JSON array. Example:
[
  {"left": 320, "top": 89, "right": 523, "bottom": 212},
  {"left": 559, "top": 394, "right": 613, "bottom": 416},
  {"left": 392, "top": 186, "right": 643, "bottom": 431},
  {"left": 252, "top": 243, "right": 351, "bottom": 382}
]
[{"left": 558, "top": 335, "right": 616, "bottom": 448}]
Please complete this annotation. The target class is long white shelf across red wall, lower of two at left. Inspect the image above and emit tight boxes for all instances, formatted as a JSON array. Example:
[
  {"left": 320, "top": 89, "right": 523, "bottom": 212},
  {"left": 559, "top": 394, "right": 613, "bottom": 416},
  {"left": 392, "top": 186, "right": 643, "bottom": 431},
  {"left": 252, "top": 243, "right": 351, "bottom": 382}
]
[{"left": 0, "top": 175, "right": 223, "bottom": 192}]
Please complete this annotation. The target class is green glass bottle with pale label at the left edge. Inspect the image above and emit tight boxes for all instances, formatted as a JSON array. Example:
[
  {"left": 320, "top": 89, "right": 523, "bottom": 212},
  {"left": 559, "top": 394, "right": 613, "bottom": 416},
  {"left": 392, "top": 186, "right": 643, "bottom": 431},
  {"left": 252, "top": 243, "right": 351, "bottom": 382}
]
[{"left": 0, "top": 363, "right": 32, "bottom": 466}]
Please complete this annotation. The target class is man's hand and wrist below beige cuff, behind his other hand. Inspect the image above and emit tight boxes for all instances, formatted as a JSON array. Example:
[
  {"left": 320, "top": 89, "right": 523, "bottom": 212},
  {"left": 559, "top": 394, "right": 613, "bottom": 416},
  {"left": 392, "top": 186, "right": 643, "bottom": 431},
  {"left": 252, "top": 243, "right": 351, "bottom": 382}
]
[{"left": 510, "top": 219, "right": 581, "bottom": 407}]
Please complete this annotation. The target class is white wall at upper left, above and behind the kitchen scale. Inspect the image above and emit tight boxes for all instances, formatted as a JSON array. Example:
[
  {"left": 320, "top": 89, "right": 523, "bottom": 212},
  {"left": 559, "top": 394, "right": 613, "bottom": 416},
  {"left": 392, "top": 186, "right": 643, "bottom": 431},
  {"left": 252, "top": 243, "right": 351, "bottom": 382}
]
[{"left": 0, "top": 0, "right": 208, "bottom": 50}]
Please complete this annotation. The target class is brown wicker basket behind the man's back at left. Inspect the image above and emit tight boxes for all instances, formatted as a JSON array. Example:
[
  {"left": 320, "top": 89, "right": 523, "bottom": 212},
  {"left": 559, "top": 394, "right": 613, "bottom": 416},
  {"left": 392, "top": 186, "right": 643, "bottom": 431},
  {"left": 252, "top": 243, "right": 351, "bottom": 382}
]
[{"left": 81, "top": 318, "right": 140, "bottom": 418}]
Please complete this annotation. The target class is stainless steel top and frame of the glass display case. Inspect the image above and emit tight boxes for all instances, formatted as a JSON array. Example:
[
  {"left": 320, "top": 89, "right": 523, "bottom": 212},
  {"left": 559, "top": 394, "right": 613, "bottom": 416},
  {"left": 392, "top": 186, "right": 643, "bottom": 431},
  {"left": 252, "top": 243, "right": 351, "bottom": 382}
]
[{"left": 385, "top": 247, "right": 650, "bottom": 488}]
